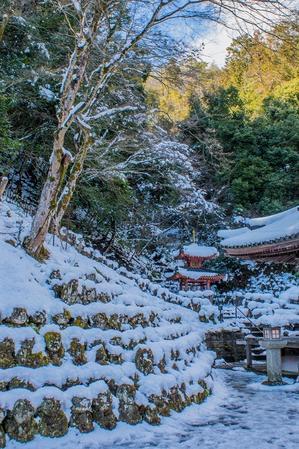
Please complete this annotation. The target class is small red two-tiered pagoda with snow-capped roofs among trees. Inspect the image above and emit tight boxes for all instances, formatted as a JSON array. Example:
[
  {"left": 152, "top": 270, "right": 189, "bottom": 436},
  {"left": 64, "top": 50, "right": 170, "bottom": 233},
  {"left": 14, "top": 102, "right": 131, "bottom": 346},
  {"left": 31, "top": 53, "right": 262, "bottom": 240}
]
[{"left": 168, "top": 243, "right": 224, "bottom": 290}]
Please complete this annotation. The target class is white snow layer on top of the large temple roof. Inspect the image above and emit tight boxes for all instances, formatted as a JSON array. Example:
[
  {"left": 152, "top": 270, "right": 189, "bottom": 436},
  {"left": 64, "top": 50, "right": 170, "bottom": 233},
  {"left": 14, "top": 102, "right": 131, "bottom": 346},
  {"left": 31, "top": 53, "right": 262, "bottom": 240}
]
[{"left": 221, "top": 207, "right": 299, "bottom": 247}]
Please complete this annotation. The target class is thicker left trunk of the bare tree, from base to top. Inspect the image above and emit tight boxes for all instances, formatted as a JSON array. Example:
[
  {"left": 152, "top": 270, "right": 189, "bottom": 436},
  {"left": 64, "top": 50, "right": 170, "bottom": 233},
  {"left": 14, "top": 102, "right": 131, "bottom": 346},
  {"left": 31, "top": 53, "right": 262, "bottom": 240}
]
[{"left": 24, "top": 3, "right": 102, "bottom": 259}]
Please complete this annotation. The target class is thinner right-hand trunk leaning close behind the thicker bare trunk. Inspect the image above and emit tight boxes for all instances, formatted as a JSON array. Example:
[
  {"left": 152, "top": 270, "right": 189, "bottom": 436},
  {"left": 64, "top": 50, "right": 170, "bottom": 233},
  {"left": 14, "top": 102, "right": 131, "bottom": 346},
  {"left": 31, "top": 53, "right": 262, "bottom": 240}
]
[{"left": 51, "top": 130, "right": 91, "bottom": 235}]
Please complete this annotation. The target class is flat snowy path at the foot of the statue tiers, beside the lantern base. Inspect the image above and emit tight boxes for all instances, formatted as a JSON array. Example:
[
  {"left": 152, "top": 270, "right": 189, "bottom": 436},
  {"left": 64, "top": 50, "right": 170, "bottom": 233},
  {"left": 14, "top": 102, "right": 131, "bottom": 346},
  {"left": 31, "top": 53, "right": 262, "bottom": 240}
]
[{"left": 8, "top": 370, "right": 299, "bottom": 449}]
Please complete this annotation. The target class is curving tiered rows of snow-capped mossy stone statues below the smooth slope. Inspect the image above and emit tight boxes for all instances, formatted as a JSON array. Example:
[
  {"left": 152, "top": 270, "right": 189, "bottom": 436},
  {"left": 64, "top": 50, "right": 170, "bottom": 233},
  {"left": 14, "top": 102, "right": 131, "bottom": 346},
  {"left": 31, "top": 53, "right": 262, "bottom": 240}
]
[{"left": 0, "top": 269, "right": 214, "bottom": 447}]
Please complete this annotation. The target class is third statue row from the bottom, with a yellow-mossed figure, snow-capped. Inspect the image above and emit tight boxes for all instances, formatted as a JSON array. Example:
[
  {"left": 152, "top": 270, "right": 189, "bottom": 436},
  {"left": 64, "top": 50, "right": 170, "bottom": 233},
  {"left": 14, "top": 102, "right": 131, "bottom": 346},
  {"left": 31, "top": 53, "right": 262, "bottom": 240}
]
[{"left": 0, "top": 324, "right": 199, "bottom": 369}]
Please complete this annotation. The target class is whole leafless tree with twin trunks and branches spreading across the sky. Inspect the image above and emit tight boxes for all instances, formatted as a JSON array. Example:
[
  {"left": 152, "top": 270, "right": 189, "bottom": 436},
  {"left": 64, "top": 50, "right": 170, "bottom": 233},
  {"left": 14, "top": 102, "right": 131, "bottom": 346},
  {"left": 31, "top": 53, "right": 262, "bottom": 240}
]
[{"left": 24, "top": 0, "right": 290, "bottom": 258}]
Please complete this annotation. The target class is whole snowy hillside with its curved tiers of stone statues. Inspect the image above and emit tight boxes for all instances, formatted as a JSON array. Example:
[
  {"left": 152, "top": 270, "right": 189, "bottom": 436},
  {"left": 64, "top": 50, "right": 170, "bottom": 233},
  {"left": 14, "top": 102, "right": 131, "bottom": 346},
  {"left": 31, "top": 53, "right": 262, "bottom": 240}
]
[{"left": 0, "top": 203, "right": 214, "bottom": 441}]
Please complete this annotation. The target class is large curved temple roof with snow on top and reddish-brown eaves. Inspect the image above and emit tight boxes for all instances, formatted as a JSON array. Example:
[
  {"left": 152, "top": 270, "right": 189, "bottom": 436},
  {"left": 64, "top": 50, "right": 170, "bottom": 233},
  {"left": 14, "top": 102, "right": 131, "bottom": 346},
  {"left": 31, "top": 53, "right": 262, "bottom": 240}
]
[{"left": 218, "top": 206, "right": 299, "bottom": 265}]
